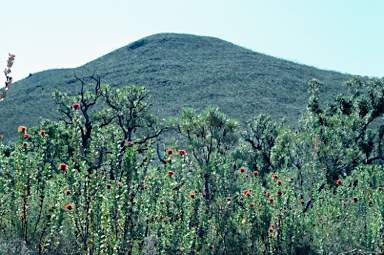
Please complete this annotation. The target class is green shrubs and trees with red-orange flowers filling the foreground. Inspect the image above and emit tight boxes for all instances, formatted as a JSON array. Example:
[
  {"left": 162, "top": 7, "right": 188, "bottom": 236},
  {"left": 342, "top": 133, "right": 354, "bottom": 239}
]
[{"left": 0, "top": 77, "right": 384, "bottom": 254}]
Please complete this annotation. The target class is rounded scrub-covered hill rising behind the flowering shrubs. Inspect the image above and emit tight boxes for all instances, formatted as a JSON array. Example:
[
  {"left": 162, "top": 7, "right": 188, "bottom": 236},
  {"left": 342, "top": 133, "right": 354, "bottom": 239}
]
[{"left": 0, "top": 33, "right": 351, "bottom": 138}]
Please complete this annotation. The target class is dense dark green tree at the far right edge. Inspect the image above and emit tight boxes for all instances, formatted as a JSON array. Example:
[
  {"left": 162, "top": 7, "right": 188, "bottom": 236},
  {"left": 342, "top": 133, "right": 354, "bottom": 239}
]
[{"left": 306, "top": 77, "right": 384, "bottom": 183}]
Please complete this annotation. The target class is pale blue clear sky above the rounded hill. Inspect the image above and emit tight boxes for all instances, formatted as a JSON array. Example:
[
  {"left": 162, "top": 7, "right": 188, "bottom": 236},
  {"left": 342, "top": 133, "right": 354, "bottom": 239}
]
[{"left": 0, "top": 0, "right": 384, "bottom": 81}]
